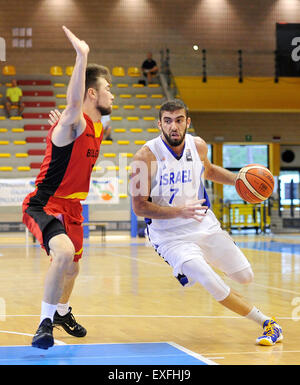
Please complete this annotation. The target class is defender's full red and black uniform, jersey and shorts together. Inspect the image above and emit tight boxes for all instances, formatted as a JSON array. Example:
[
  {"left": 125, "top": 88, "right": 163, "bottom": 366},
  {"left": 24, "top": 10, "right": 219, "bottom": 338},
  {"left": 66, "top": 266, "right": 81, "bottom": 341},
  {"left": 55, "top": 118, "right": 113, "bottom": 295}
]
[{"left": 22, "top": 114, "right": 103, "bottom": 261}]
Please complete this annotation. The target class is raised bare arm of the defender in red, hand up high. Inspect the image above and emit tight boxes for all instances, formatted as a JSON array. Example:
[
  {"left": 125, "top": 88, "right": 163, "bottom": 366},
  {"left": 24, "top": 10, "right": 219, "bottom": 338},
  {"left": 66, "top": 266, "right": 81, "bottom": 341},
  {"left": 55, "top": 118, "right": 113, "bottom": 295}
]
[{"left": 52, "top": 26, "right": 89, "bottom": 146}]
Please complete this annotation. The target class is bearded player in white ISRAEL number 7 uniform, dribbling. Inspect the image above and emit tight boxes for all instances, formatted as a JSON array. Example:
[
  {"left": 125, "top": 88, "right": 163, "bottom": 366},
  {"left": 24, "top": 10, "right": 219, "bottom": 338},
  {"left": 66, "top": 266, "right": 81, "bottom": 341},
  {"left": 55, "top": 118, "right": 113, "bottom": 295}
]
[{"left": 131, "top": 100, "right": 283, "bottom": 345}]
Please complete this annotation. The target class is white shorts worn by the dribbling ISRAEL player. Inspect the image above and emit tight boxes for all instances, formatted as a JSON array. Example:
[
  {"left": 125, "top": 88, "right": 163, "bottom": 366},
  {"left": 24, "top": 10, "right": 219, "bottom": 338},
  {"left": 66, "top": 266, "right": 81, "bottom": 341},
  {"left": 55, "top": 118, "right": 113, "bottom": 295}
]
[{"left": 149, "top": 210, "right": 250, "bottom": 277}]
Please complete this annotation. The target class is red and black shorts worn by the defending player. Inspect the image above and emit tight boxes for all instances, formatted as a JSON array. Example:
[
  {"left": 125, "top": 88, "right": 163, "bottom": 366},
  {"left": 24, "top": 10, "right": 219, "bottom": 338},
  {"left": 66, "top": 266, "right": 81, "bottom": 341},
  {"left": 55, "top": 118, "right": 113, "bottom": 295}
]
[{"left": 22, "top": 189, "right": 83, "bottom": 262}]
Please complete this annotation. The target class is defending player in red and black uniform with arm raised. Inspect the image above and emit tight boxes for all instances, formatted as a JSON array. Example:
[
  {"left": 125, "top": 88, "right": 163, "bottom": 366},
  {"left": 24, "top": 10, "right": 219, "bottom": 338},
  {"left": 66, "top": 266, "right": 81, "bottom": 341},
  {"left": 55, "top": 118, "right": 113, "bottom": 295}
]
[{"left": 23, "top": 27, "right": 114, "bottom": 349}]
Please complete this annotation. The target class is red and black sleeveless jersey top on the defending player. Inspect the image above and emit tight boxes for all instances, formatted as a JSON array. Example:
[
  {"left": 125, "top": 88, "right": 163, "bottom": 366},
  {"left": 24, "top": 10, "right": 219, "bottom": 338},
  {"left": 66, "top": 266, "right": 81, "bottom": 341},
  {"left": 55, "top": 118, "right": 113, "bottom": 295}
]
[{"left": 35, "top": 114, "right": 103, "bottom": 200}]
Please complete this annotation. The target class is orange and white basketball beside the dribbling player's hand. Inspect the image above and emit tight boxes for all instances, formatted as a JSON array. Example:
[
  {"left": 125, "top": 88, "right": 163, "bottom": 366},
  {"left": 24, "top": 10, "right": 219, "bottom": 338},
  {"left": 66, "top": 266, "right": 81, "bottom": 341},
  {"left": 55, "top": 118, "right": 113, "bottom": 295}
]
[{"left": 235, "top": 164, "right": 274, "bottom": 203}]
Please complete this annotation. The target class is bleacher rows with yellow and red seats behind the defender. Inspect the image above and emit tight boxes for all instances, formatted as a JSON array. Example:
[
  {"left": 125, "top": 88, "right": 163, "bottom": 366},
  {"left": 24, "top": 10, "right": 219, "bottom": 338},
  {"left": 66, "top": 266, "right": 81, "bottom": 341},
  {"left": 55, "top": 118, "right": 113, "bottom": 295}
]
[{"left": 0, "top": 66, "right": 165, "bottom": 178}]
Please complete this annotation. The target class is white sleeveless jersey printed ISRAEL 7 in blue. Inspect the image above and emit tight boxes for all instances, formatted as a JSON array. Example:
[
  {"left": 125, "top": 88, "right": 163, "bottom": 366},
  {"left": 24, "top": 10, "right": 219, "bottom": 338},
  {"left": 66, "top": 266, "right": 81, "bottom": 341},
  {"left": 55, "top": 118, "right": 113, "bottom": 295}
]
[{"left": 145, "top": 134, "right": 210, "bottom": 230}]
